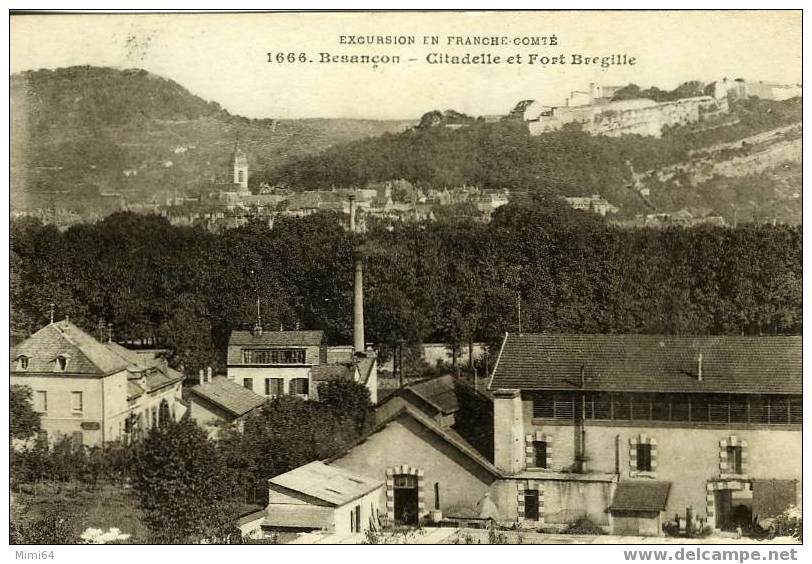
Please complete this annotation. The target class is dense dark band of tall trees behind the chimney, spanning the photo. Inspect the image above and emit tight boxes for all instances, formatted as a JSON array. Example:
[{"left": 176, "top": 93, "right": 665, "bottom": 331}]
[{"left": 10, "top": 197, "right": 802, "bottom": 370}]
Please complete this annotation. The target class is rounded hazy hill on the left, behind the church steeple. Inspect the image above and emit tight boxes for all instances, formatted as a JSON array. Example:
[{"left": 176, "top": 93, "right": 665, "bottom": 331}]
[{"left": 11, "top": 66, "right": 413, "bottom": 209}]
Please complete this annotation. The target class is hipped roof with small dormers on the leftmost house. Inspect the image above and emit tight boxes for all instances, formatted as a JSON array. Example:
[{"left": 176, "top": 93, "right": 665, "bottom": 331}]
[{"left": 11, "top": 320, "right": 128, "bottom": 376}]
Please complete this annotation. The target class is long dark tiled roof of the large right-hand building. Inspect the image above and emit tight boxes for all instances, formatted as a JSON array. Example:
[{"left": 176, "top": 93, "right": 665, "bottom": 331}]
[{"left": 489, "top": 334, "right": 802, "bottom": 394}]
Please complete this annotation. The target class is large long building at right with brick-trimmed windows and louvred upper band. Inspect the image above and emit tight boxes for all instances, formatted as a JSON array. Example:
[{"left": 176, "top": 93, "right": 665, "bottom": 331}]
[{"left": 489, "top": 334, "right": 802, "bottom": 535}]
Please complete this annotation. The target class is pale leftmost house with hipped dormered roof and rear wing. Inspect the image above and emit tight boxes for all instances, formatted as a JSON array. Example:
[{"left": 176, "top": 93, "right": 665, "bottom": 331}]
[{"left": 10, "top": 319, "right": 186, "bottom": 446}]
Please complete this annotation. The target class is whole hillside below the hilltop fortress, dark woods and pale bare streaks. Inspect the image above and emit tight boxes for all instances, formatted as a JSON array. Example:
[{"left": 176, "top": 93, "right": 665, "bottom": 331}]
[{"left": 269, "top": 98, "right": 801, "bottom": 223}]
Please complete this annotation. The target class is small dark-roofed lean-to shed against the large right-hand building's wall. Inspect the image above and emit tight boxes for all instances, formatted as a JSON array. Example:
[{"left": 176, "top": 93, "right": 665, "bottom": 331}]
[{"left": 609, "top": 481, "right": 671, "bottom": 536}]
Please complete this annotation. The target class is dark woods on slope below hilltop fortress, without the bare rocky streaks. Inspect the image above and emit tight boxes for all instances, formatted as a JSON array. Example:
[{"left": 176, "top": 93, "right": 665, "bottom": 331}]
[{"left": 266, "top": 98, "right": 801, "bottom": 214}]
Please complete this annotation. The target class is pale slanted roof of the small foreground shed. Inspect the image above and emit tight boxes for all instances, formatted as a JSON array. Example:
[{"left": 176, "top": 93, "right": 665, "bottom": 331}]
[{"left": 268, "top": 461, "right": 383, "bottom": 507}]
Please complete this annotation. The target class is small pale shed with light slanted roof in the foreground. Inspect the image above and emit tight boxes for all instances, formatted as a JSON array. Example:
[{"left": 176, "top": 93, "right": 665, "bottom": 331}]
[{"left": 262, "top": 462, "right": 384, "bottom": 533}]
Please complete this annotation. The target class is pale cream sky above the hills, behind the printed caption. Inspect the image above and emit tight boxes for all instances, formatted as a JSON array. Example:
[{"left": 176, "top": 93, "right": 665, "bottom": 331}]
[{"left": 10, "top": 11, "right": 801, "bottom": 119}]
